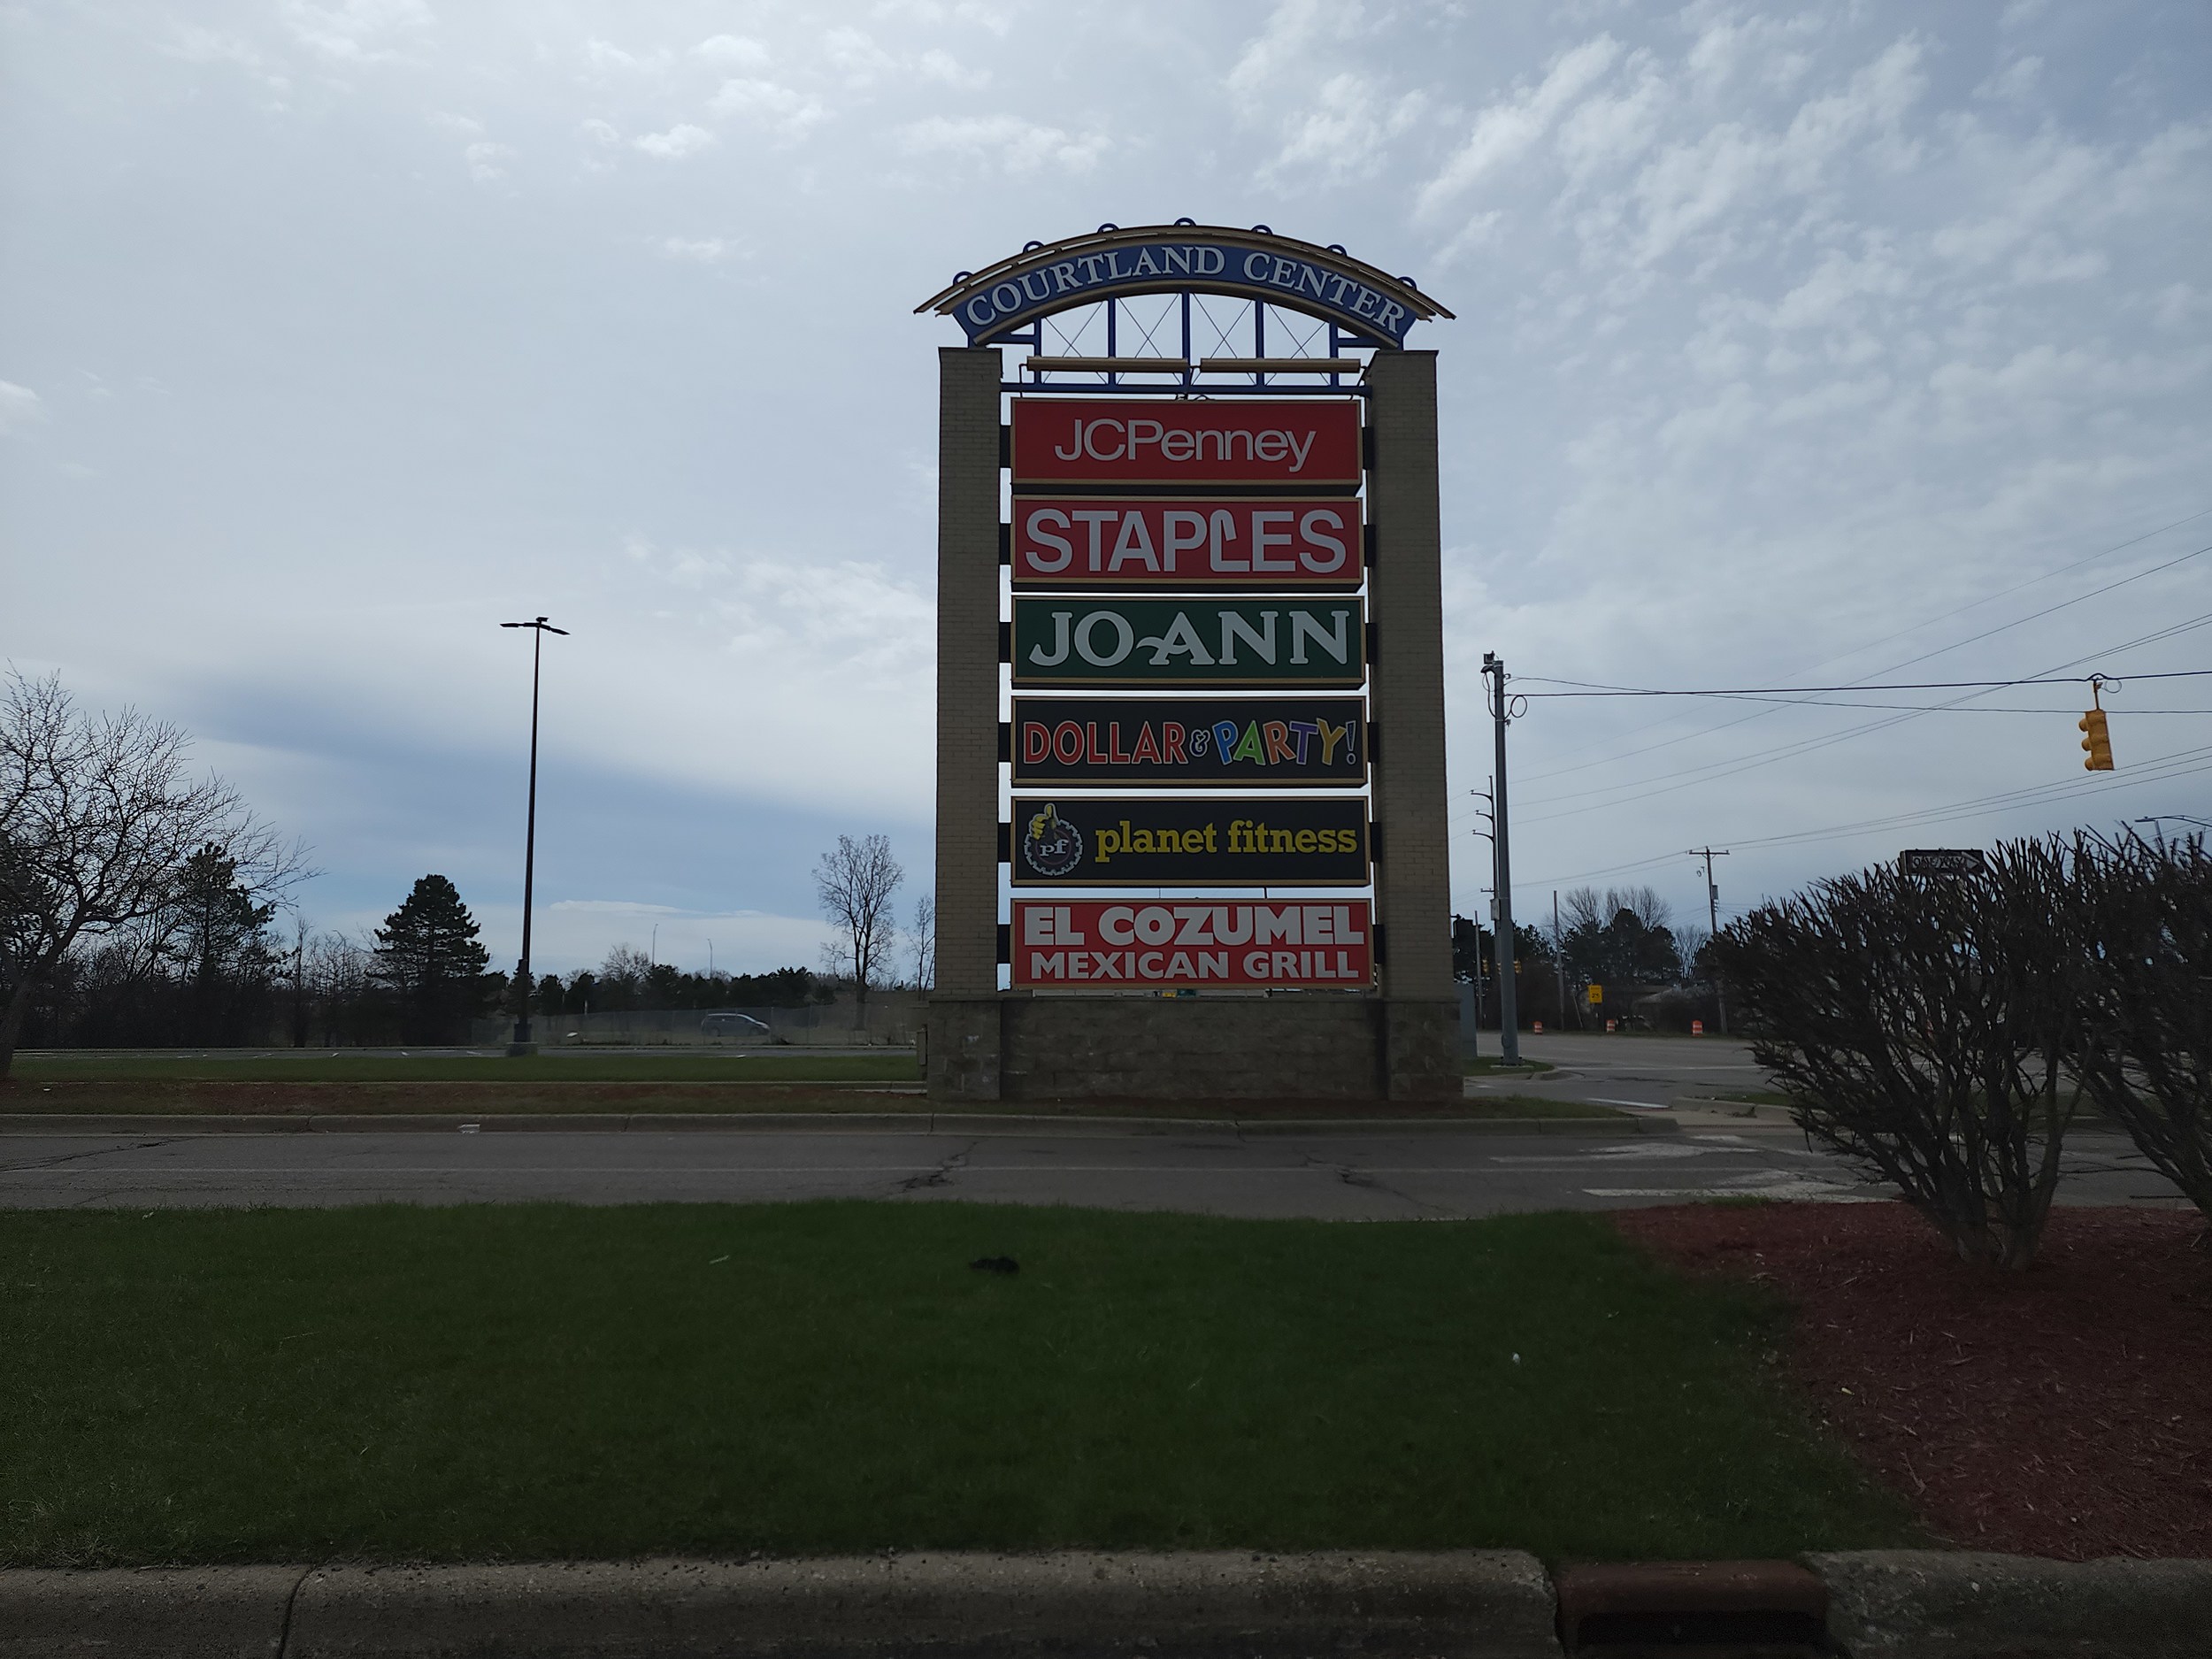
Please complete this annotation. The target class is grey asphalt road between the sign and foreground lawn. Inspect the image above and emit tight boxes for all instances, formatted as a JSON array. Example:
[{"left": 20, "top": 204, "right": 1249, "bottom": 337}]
[{"left": 0, "top": 1124, "right": 2172, "bottom": 1221}]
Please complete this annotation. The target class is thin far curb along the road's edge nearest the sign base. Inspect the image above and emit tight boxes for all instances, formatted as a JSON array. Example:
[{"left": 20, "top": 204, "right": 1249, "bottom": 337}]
[{"left": 0, "top": 1113, "right": 1681, "bottom": 1137}]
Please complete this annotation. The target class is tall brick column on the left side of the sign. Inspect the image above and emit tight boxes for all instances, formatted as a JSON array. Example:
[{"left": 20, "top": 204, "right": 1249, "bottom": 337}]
[{"left": 929, "top": 348, "right": 1000, "bottom": 1100}]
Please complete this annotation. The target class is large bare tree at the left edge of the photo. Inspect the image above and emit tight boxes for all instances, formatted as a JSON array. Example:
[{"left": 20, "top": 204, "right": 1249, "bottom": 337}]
[{"left": 0, "top": 672, "right": 308, "bottom": 1078}]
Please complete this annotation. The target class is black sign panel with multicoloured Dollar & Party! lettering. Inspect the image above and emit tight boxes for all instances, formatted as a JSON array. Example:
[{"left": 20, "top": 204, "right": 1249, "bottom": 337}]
[{"left": 1013, "top": 697, "right": 1367, "bottom": 790}]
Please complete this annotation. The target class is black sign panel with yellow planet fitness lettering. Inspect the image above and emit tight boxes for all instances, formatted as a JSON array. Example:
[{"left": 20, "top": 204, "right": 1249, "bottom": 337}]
[{"left": 1009, "top": 796, "right": 1367, "bottom": 887}]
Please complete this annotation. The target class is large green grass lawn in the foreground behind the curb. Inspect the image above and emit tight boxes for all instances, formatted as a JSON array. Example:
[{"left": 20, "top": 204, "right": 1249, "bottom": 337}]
[{"left": 0, "top": 1203, "right": 1916, "bottom": 1564}]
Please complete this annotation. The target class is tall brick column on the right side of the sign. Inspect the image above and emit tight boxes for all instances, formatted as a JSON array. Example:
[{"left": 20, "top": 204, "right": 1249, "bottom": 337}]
[{"left": 1371, "top": 352, "right": 1460, "bottom": 1100}]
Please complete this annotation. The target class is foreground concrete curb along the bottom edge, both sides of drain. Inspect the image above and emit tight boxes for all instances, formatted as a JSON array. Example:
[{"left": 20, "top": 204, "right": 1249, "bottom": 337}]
[{"left": 0, "top": 1551, "right": 2212, "bottom": 1659}]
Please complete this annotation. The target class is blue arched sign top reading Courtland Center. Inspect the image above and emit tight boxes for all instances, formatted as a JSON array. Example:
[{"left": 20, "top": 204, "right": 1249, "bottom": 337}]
[{"left": 914, "top": 224, "right": 1451, "bottom": 348}]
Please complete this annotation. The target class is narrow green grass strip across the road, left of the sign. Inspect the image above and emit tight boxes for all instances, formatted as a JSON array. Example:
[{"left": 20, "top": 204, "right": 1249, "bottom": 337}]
[{"left": 16, "top": 1066, "right": 920, "bottom": 1084}]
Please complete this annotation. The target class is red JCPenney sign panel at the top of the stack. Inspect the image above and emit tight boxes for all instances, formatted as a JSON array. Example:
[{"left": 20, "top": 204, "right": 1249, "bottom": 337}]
[{"left": 1013, "top": 398, "right": 1361, "bottom": 489}]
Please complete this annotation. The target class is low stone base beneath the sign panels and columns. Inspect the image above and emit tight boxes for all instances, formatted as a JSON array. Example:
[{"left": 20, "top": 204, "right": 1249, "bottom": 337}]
[{"left": 929, "top": 994, "right": 1463, "bottom": 1102}]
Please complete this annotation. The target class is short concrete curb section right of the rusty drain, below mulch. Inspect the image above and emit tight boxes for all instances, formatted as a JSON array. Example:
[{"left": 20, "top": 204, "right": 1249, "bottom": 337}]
[{"left": 1803, "top": 1551, "right": 2212, "bottom": 1659}]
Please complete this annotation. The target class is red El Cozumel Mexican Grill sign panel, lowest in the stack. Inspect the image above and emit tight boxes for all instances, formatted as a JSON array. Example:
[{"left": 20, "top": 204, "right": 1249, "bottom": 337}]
[{"left": 1013, "top": 898, "right": 1374, "bottom": 991}]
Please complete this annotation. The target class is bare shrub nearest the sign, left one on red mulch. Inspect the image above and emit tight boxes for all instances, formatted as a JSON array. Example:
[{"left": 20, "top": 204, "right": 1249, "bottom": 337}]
[{"left": 1715, "top": 841, "right": 2084, "bottom": 1270}]
